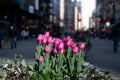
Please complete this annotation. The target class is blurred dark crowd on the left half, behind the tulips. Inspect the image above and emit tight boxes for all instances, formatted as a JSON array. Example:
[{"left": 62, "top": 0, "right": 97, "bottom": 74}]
[{"left": 0, "top": 23, "right": 62, "bottom": 49}]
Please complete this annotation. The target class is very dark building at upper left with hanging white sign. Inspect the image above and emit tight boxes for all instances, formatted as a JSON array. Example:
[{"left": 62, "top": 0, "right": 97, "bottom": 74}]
[{"left": 0, "top": 0, "right": 40, "bottom": 26}]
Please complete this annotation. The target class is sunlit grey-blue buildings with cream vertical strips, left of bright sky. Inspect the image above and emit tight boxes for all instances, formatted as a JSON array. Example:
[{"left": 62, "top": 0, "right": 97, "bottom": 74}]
[{"left": 53, "top": 0, "right": 82, "bottom": 30}]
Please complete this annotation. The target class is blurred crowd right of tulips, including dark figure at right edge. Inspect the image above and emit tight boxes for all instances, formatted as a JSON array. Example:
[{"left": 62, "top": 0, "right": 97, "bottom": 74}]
[{"left": 89, "top": 24, "right": 120, "bottom": 52}]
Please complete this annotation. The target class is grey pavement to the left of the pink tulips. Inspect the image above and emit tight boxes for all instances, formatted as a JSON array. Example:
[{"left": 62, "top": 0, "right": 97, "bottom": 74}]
[{"left": 0, "top": 39, "right": 36, "bottom": 64}]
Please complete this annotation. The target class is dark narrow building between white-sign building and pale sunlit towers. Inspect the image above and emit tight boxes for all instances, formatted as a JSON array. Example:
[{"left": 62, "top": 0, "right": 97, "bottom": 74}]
[{"left": 39, "top": 0, "right": 54, "bottom": 22}]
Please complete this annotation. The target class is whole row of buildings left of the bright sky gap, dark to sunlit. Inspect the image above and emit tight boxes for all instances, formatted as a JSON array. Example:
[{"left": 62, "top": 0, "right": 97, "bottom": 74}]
[{"left": 0, "top": 0, "right": 82, "bottom": 37}]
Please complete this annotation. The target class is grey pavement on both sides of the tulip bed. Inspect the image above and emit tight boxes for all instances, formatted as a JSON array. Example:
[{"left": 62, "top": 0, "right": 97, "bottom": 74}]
[{"left": 0, "top": 39, "right": 120, "bottom": 77}]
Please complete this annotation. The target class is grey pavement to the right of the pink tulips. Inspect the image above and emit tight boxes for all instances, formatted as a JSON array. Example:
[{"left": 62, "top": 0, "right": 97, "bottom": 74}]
[{"left": 86, "top": 39, "right": 120, "bottom": 77}]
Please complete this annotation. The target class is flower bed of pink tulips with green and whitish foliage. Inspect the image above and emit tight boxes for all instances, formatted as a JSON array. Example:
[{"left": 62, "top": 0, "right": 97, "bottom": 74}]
[{"left": 0, "top": 32, "right": 116, "bottom": 80}]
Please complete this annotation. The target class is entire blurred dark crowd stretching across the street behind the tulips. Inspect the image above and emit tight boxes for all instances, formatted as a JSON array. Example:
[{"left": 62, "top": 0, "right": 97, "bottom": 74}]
[{"left": 0, "top": 23, "right": 120, "bottom": 51}]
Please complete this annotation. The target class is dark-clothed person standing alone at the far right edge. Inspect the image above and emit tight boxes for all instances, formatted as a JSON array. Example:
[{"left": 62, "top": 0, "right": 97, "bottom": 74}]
[{"left": 111, "top": 24, "right": 120, "bottom": 52}]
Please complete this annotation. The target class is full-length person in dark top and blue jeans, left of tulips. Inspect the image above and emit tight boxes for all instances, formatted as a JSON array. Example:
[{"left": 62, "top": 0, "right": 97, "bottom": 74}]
[{"left": 8, "top": 26, "right": 17, "bottom": 49}]
